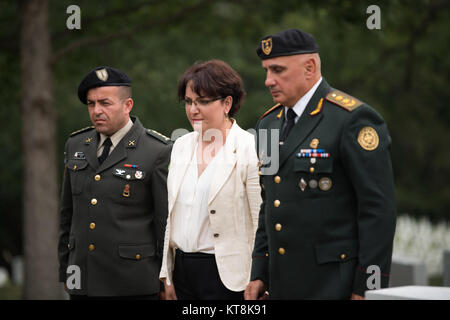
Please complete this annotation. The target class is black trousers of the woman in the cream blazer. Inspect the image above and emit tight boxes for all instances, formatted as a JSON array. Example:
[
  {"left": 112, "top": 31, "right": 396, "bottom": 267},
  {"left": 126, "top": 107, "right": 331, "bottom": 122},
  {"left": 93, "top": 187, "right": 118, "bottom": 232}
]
[{"left": 173, "top": 249, "right": 244, "bottom": 300}]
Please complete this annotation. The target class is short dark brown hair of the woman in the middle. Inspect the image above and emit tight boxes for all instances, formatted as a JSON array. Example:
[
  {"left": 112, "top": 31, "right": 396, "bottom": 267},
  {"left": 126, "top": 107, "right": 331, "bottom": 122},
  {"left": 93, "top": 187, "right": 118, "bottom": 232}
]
[{"left": 178, "top": 59, "right": 245, "bottom": 117}]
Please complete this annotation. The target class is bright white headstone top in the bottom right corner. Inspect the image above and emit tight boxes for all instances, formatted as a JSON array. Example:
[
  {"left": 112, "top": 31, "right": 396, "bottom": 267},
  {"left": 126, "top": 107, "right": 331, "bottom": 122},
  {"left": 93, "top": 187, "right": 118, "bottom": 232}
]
[{"left": 365, "top": 286, "right": 450, "bottom": 300}]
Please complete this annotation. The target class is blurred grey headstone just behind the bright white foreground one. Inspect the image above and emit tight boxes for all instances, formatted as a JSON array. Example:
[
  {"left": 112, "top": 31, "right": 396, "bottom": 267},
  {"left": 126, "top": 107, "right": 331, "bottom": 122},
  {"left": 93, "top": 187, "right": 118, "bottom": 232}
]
[{"left": 389, "top": 256, "right": 428, "bottom": 287}]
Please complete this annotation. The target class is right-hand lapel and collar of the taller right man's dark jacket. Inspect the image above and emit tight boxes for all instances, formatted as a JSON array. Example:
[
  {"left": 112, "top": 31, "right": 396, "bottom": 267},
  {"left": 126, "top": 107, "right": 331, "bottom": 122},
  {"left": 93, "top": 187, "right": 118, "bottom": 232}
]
[{"left": 280, "top": 79, "right": 331, "bottom": 167}]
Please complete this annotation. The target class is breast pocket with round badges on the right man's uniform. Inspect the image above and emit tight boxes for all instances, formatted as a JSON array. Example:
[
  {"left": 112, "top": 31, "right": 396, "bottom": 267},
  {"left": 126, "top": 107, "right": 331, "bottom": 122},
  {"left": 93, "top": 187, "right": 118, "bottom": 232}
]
[{"left": 294, "top": 158, "right": 333, "bottom": 196}]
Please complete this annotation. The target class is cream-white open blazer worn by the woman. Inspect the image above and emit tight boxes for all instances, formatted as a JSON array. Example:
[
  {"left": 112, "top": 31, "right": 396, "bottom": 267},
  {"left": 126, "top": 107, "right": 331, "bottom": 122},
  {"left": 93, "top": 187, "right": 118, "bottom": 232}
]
[{"left": 159, "top": 120, "right": 262, "bottom": 291}]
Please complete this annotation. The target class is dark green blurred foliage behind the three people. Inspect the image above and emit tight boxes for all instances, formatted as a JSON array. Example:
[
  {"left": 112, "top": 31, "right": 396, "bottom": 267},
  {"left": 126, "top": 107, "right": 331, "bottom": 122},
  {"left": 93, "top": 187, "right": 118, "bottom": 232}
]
[{"left": 0, "top": 0, "right": 450, "bottom": 270}]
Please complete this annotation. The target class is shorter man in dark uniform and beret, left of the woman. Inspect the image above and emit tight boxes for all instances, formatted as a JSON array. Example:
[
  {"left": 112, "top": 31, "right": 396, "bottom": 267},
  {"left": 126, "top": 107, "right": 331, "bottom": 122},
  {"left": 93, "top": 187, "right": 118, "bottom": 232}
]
[{"left": 58, "top": 67, "right": 172, "bottom": 299}]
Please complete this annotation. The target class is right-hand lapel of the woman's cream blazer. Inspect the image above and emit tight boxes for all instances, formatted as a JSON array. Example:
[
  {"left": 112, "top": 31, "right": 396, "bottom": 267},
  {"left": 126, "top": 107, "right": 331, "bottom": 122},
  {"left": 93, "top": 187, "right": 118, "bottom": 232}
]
[{"left": 208, "top": 120, "right": 240, "bottom": 204}]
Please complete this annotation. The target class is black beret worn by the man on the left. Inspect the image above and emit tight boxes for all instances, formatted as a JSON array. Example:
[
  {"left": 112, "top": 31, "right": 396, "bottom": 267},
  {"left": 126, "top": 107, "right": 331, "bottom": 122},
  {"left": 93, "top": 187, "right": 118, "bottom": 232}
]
[{"left": 78, "top": 66, "right": 131, "bottom": 104}]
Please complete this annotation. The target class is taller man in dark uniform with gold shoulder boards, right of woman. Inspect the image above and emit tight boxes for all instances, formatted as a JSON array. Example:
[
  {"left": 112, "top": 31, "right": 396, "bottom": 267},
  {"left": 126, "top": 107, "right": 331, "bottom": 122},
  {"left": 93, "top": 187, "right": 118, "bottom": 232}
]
[{"left": 245, "top": 29, "right": 396, "bottom": 299}]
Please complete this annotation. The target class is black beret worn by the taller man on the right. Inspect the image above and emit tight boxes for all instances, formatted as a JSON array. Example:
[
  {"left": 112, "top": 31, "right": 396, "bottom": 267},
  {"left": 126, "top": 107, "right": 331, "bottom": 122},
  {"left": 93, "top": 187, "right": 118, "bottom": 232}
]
[{"left": 256, "top": 29, "right": 319, "bottom": 60}]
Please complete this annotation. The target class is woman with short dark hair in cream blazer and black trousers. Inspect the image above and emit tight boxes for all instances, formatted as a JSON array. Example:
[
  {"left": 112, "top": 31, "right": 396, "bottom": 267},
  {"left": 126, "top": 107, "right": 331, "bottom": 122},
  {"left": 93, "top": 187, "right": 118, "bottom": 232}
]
[{"left": 160, "top": 60, "right": 261, "bottom": 300}]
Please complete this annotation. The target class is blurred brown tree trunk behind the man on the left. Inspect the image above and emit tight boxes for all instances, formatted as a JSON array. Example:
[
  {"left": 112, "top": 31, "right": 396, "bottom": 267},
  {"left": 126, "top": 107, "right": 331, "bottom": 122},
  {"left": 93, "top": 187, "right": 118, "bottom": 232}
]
[{"left": 20, "top": 0, "right": 61, "bottom": 299}]
